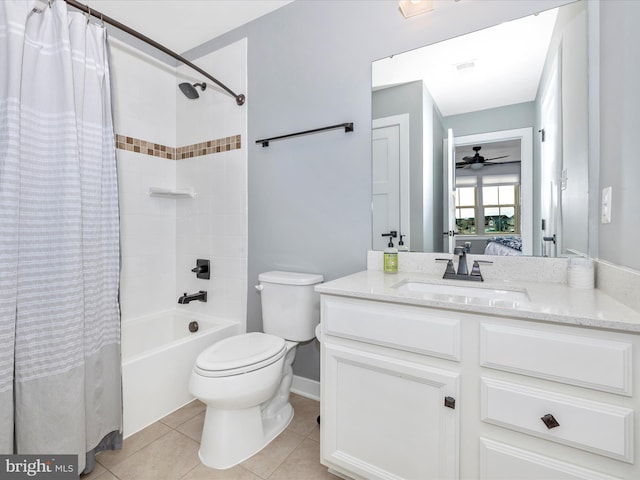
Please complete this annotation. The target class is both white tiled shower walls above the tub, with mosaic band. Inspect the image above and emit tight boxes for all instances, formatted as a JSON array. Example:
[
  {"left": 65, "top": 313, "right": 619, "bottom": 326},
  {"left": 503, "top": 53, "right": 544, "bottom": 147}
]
[{"left": 111, "top": 36, "right": 247, "bottom": 326}]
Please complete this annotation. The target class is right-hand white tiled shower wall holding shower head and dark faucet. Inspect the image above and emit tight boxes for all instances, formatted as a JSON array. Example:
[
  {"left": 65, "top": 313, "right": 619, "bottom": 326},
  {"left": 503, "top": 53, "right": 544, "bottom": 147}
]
[{"left": 174, "top": 39, "right": 249, "bottom": 329}]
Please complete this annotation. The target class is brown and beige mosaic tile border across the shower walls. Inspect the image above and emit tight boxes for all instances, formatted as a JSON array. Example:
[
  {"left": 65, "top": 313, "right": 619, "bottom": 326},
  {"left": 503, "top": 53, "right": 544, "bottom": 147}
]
[{"left": 116, "top": 134, "right": 242, "bottom": 160}]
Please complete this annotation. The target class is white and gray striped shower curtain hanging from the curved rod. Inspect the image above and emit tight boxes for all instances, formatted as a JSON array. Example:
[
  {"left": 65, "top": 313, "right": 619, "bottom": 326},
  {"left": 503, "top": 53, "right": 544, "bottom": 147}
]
[{"left": 0, "top": 0, "right": 122, "bottom": 472}]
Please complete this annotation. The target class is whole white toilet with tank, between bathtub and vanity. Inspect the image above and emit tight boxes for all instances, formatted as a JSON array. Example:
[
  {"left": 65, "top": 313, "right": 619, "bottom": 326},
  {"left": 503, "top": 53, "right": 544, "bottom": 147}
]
[{"left": 189, "top": 271, "right": 323, "bottom": 469}]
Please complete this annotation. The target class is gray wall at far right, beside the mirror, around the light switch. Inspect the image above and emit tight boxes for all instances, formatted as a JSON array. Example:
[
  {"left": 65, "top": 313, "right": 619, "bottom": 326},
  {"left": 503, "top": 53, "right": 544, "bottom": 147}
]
[{"left": 590, "top": 1, "right": 640, "bottom": 270}]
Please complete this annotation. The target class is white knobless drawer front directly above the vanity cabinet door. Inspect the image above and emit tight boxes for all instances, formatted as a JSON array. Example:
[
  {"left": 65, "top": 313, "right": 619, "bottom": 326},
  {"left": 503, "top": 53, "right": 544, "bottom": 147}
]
[{"left": 321, "top": 295, "right": 463, "bottom": 360}]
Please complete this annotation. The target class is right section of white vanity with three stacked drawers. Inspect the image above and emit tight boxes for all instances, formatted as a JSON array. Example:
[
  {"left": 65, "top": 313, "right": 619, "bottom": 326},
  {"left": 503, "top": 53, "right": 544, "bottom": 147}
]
[{"left": 479, "top": 316, "right": 640, "bottom": 480}]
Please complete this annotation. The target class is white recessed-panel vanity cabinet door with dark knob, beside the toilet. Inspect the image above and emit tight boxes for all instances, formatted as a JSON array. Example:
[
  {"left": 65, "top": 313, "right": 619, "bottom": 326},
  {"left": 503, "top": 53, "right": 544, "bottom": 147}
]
[{"left": 321, "top": 337, "right": 459, "bottom": 480}]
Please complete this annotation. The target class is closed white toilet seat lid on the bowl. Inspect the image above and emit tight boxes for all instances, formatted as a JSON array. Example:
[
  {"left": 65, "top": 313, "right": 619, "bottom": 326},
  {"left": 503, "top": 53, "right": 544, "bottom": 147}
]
[{"left": 195, "top": 332, "right": 287, "bottom": 377}]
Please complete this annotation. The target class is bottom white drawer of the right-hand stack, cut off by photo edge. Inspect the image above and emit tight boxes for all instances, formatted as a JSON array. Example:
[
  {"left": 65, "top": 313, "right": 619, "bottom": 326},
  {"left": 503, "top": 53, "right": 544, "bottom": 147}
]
[{"left": 480, "top": 438, "right": 620, "bottom": 480}]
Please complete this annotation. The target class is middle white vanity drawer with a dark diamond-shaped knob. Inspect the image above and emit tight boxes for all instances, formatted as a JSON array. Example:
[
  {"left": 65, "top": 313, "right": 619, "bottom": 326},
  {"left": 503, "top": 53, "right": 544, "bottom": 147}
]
[{"left": 480, "top": 378, "right": 633, "bottom": 463}]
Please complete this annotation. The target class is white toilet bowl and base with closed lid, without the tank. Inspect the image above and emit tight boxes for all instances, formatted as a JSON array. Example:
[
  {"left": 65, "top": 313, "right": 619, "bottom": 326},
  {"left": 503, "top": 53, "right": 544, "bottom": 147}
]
[{"left": 189, "top": 332, "right": 296, "bottom": 469}]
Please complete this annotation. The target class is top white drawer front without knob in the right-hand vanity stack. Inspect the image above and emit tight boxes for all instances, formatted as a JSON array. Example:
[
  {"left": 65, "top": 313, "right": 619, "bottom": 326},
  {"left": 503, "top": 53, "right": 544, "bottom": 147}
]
[{"left": 480, "top": 322, "right": 633, "bottom": 396}]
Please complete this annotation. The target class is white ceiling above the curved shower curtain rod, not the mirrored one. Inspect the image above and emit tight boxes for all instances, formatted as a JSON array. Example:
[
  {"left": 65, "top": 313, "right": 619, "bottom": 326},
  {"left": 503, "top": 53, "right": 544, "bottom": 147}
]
[{"left": 79, "top": 0, "right": 293, "bottom": 53}]
